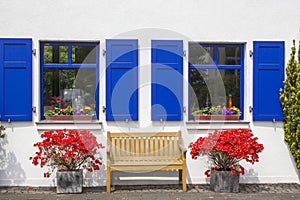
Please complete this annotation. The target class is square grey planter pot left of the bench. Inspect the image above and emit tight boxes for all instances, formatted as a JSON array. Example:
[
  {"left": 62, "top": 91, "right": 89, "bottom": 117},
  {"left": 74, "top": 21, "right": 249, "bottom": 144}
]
[{"left": 56, "top": 170, "right": 83, "bottom": 194}]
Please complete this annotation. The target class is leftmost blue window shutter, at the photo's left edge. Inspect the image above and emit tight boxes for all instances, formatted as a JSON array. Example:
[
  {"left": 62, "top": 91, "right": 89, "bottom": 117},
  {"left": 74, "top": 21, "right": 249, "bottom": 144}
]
[{"left": 0, "top": 39, "right": 32, "bottom": 121}]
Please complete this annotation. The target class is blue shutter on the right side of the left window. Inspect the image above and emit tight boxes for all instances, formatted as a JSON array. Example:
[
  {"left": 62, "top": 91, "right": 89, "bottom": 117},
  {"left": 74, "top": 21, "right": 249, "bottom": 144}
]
[{"left": 106, "top": 39, "right": 138, "bottom": 121}]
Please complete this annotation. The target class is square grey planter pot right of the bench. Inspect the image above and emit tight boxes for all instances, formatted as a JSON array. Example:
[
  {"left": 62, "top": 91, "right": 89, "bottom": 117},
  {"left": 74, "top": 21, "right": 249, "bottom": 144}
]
[{"left": 210, "top": 171, "right": 239, "bottom": 192}]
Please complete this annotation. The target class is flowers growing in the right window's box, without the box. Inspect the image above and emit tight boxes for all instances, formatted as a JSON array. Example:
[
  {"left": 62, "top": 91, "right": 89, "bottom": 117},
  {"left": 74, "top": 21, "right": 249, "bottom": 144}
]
[{"left": 192, "top": 105, "right": 241, "bottom": 115}]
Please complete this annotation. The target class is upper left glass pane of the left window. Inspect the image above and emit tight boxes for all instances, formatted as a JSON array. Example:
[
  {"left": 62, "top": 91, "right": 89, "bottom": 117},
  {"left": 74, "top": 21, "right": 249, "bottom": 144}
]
[{"left": 44, "top": 45, "right": 68, "bottom": 64}]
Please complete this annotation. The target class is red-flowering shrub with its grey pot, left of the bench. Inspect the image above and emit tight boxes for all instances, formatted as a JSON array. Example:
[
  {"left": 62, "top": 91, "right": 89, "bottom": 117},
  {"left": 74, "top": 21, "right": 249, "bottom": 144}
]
[{"left": 29, "top": 129, "right": 104, "bottom": 193}]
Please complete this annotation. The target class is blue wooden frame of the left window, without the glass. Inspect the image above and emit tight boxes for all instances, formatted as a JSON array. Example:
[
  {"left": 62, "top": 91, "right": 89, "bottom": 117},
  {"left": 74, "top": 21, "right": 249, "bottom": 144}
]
[{"left": 40, "top": 41, "right": 100, "bottom": 120}]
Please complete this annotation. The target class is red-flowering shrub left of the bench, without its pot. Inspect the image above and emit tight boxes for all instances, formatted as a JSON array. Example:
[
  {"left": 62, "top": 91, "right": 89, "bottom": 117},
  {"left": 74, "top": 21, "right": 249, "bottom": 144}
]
[{"left": 29, "top": 129, "right": 104, "bottom": 177}]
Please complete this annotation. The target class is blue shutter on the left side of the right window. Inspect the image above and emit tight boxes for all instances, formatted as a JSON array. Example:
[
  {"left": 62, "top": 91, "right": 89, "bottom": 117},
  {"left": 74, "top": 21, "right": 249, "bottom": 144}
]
[{"left": 151, "top": 40, "right": 183, "bottom": 121}]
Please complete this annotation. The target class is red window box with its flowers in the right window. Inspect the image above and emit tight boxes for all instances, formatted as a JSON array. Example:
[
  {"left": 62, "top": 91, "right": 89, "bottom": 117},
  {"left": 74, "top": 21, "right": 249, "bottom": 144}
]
[{"left": 192, "top": 105, "right": 241, "bottom": 120}]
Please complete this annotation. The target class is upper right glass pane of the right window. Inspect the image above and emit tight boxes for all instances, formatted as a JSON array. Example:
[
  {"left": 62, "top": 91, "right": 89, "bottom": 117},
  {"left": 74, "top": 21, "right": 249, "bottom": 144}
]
[{"left": 218, "top": 47, "right": 241, "bottom": 65}]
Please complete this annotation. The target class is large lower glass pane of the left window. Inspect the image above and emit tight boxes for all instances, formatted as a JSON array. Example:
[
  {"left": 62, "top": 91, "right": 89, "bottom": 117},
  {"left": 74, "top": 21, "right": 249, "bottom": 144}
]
[{"left": 44, "top": 68, "right": 96, "bottom": 115}]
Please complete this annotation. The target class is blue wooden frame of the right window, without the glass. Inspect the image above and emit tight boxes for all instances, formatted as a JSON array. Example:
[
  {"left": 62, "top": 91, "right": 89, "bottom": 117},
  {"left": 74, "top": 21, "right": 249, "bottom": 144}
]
[{"left": 188, "top": 41, "right": 245, "bottom": 121}]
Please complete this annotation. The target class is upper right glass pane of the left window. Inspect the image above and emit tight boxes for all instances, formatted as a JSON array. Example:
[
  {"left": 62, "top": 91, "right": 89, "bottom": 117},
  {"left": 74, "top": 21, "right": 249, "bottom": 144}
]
[{"left": 72, "top": 46, "right": 96, "bottom": 64}]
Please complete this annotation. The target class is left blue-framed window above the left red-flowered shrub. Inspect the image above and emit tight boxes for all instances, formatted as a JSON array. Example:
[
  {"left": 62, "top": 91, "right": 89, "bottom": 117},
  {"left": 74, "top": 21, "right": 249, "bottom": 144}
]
[{"left": 41, "top": 42, "right": 99, "bottom": 118}]
